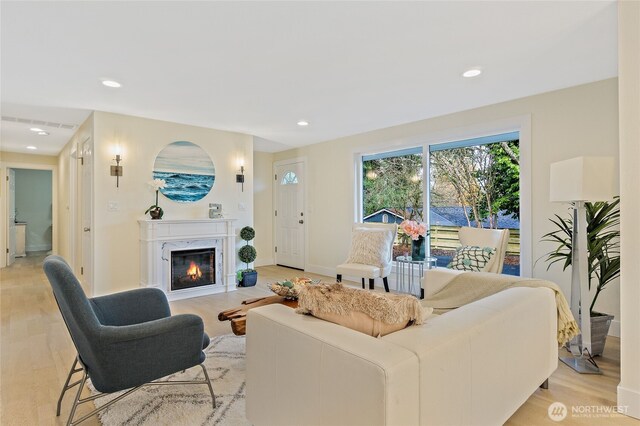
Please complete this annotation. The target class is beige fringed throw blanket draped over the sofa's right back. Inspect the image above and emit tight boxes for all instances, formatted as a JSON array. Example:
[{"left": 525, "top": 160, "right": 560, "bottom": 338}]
[{"left": 424, "top": 272, "right": 580, "bottom": 344}]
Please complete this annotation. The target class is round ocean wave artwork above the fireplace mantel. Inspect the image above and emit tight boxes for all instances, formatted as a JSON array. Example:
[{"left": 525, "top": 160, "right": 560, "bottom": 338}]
[{"left": 153, "top": 141, "right": 216, "bottom": 203}]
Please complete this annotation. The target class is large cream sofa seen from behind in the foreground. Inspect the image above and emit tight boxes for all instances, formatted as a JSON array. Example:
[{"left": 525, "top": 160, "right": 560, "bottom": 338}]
[{"left": 246, "top": 282, "right": 558, "bottom": 426}]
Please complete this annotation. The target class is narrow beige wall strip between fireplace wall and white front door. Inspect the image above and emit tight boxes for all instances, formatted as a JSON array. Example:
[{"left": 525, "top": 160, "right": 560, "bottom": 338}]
[{"left": 253, "top": 152, "right": 274, "bottom": 266}]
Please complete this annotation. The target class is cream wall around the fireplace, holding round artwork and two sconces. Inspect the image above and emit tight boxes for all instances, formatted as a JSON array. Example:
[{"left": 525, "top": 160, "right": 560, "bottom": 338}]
[{"left": 60, "top": 112, "right": 253, "bottom": 295}]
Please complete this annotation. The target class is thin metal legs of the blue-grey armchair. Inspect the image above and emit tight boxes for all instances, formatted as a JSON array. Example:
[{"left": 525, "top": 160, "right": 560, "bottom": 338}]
[{"left": 56, "top": 357, "right": 216, "bottom": 426}]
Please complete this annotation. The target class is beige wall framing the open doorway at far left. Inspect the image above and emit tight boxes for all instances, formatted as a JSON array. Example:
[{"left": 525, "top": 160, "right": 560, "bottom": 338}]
[{"left": 0, "top": 151, "right": 59, "bottom": 268}]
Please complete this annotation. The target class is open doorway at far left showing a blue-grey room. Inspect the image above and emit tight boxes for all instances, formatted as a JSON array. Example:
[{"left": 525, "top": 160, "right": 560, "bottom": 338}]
[{"left": 6, "top": 167, "right": 54, "bottom": 266}]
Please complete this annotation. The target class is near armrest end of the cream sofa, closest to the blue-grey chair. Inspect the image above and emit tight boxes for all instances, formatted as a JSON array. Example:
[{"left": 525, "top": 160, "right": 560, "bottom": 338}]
[{"left": 246, "top": 305, "right": 419, "bottom": 425}]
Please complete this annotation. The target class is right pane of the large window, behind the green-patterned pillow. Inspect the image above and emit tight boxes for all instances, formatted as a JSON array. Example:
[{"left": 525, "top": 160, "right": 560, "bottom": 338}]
[{"left": 429, "top": 132, "right": 520, "bottom": 275}]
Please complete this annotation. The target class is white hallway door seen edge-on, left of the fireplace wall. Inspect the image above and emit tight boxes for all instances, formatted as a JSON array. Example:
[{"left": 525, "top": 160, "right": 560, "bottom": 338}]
[{"left": 80, "top": 139, "right": 93, "bottom": 295}]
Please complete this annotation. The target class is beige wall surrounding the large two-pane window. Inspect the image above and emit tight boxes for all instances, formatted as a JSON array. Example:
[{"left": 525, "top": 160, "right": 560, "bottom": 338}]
[{"left": 256, "top": 79, "right": 619, "bottom": 320}]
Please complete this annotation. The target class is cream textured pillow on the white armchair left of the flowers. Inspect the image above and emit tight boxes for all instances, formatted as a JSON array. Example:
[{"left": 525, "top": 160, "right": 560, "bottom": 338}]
[{"left": 346, "top": 228, "right": 393, "bottom": 269}]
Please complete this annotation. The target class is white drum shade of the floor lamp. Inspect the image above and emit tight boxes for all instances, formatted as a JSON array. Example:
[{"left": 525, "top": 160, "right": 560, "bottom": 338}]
[{"left": 550, "top": 157, "right": 615, "bottom": 202}]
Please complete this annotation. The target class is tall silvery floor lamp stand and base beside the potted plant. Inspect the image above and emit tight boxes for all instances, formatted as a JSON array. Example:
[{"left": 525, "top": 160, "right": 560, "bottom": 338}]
[{"left": 560, "top": 201, "right": 602, "bottom": 374}]
